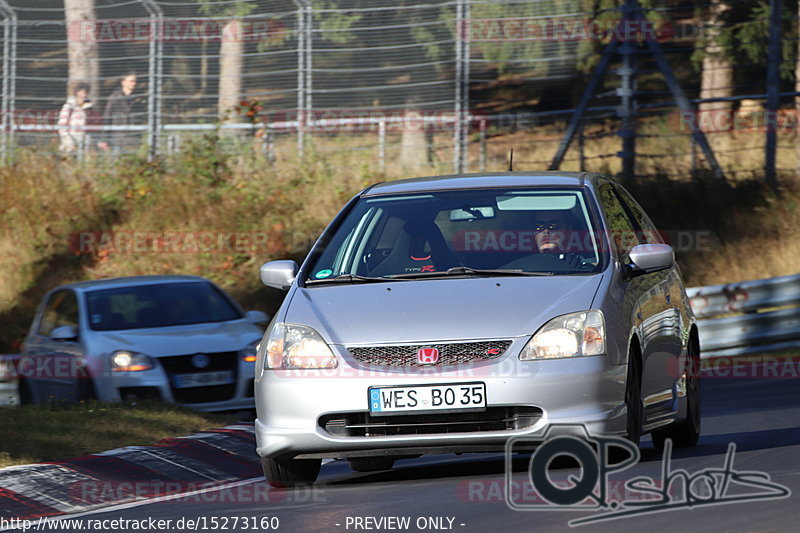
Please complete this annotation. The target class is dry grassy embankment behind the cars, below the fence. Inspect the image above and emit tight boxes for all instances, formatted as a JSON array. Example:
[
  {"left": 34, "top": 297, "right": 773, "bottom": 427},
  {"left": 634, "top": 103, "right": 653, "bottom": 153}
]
[{"left": 0, "top": 128, "right": 800, "bottom": 353}]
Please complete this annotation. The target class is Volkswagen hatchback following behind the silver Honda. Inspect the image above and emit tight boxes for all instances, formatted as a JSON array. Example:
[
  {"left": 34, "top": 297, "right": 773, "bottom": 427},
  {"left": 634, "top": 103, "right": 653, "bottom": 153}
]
[{"left": 19, "top": 275, "right": 268, "bottom": 411}]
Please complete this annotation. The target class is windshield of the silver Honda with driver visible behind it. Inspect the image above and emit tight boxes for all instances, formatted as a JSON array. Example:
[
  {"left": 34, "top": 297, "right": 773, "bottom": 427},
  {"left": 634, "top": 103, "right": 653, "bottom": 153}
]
[{"left": 307, "top": 188, "right": 601, "bottom": 283}]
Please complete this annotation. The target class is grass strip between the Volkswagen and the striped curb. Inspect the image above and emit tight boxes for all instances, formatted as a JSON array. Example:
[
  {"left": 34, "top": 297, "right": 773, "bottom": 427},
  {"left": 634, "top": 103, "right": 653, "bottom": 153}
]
[{"left": 0, "top": 402, "right": 236, "bottom": 468}]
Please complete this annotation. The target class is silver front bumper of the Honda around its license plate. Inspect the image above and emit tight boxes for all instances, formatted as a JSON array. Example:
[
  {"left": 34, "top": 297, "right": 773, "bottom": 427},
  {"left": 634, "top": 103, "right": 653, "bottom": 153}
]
[{"left": 255, "top": 350, "right": 627, "bottom": 457}]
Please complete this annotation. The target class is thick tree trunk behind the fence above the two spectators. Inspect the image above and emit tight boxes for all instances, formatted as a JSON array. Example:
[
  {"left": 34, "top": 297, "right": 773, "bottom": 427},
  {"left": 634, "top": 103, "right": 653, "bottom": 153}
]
[{"left": 64, "top": 0, "right": 100, "bottom": 98}]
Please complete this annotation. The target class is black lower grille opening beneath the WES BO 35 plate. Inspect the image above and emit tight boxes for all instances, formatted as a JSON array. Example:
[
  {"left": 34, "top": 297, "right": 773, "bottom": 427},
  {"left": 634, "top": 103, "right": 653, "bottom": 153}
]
[{"left": 319, "top": 406, "right": 542, "bottom": 437}]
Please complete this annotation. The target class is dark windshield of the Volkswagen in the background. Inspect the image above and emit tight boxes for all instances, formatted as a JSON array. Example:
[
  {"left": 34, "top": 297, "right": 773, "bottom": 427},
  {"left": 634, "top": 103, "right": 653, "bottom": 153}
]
[{"left": 86, "top": 281, "right": 242, "bottom": 331}]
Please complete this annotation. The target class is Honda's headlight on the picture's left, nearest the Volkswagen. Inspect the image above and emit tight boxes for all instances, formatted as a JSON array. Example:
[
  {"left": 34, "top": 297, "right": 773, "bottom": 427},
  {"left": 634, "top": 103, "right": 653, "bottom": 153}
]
[{"left": 258, "top": 322, "right": 339, "bottom": 370}]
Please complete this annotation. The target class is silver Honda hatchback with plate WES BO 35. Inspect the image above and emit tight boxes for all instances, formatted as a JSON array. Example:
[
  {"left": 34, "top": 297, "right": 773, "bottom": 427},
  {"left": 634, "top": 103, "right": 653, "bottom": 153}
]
[{"left": 255, "top": 172, "right": 700, "bottom": 485}]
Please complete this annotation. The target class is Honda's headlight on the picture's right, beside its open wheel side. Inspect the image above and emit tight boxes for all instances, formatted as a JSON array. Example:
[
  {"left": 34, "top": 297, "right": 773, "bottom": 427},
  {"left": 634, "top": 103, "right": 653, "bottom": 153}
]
[{"left": 519, "top": 310, "right": 606, "bottom": 361}]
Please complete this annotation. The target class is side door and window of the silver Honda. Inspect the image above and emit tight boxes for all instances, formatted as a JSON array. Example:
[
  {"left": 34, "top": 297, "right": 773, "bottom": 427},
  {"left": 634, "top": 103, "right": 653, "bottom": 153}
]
[{"left": 599, "top": 183, "right": 674, "bottom": 421}]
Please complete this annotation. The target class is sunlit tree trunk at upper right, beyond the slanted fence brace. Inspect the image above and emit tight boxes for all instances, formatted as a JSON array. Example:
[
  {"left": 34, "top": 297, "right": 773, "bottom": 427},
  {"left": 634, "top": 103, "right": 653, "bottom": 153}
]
[{"left": 700, "top": 0, "right": 733, "bottom": 117}]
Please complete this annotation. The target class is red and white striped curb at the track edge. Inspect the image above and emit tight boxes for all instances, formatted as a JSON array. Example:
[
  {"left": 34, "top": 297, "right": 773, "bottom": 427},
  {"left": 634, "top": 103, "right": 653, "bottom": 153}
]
[{"left": 0, "top": 424, "right": 268, "bottom": 529}]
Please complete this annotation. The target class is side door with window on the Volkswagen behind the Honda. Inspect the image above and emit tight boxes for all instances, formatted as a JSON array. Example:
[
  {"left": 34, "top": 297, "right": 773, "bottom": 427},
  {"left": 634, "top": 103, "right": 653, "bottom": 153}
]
[{"left": 20, "top": 289, "right": 85, "bottom": 402}]
